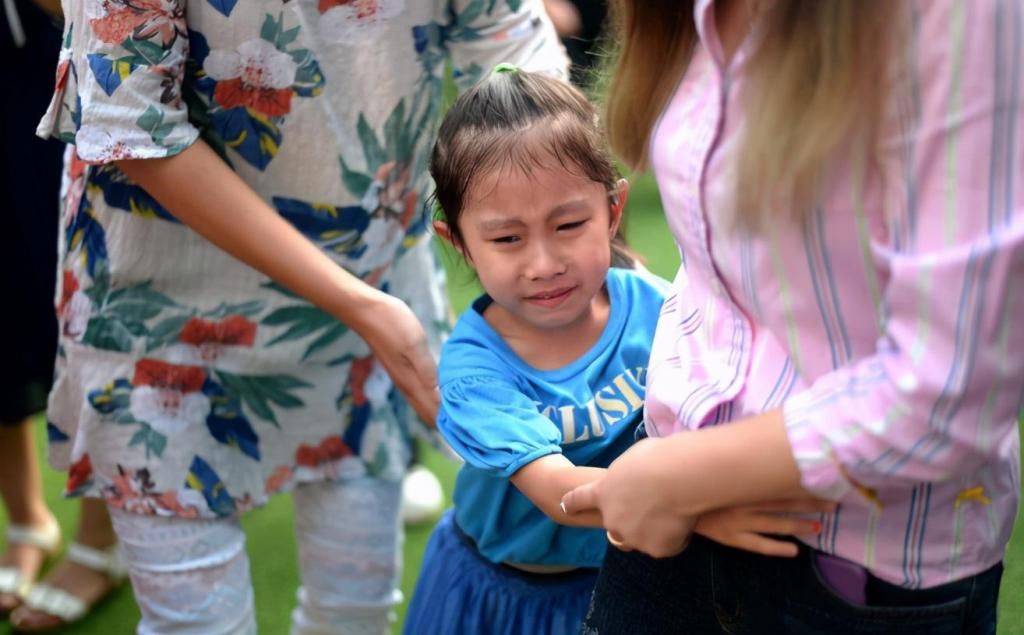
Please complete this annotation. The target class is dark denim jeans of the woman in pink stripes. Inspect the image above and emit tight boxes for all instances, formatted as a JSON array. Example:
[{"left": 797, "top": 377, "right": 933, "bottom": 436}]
[{"left": 583, "top": 536, "right": 1002, "bottom": 635}]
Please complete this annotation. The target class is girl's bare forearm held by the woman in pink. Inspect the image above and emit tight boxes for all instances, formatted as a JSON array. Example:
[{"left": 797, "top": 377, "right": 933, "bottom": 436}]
[{"left": 510, "top": 454, "right": 605, "bottom": 527}]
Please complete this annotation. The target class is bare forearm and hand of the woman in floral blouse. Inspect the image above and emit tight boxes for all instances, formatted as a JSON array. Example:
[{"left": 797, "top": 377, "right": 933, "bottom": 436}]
[{"left": 117, "top": 140, "right": 439, "bottom": 423}]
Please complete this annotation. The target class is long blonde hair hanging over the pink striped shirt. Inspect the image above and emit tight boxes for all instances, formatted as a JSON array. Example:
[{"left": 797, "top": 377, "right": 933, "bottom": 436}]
[{"left": 605, "top": 0, "right": 903, "bottom": 228}]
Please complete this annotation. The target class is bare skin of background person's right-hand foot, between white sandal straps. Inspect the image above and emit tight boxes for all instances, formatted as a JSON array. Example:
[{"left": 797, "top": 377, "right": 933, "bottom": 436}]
[{"left": 11, "top": 499, "right": 117, "bottom": 632}]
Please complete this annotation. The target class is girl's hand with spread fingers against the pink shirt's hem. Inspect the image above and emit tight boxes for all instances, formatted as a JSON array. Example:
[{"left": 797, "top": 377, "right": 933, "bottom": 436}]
[{"left": 694, "top": 499, "right": 836, "bottom": 558}]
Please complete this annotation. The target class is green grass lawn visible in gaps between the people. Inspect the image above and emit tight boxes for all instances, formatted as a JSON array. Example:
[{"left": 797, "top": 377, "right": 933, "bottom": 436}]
[{"left": 0, "top": 171, "right": 1024, "bottom": 635}]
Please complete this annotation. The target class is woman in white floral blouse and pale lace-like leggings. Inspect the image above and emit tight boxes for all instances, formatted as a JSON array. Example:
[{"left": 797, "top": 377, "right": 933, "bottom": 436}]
[{"left": 28, "top": 0, "right": 565, "bottom": 633}]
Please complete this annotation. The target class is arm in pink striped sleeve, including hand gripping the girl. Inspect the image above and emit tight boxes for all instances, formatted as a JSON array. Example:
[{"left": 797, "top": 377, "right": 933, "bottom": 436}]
[{"left": 566, "top": 2, "right": 1024, "bottom": 553}]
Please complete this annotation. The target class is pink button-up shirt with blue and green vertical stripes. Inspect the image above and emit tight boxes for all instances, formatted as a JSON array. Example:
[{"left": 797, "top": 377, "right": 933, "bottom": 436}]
[{"left": 646, "top": 0, "right": 1024, "bottom": 589}]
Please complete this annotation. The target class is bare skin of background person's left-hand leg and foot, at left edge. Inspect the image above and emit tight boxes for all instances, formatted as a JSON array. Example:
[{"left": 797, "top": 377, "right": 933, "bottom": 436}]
[{"left": 0, "top": 419, "right": 51, "bottom": 612}]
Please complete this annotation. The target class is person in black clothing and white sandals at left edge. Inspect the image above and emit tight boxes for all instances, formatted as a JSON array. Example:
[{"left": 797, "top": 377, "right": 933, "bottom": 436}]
[{"left": 0, "top": 0, "right": 124, "bottom": 632}]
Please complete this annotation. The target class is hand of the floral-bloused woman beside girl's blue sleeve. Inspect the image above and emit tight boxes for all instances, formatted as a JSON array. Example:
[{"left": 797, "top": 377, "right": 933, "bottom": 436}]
[{"left": 351, "top": 290, "right": 440, "bottom": 427}]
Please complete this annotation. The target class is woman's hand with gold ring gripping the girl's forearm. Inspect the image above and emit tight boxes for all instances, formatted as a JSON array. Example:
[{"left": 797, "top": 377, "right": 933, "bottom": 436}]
[{"left": 562, "top": 438, "right": 696, "bottom": 558}]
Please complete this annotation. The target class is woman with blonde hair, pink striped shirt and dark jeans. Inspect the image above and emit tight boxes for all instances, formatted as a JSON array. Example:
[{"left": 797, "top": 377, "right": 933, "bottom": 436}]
[{"left": 564, "top": 0, "right": 1024, "bottom": 633}]
